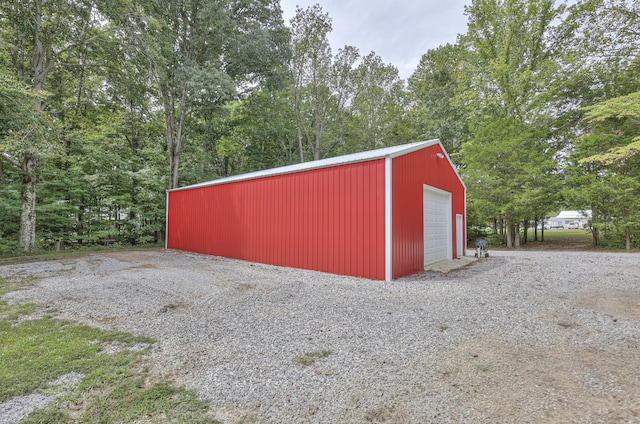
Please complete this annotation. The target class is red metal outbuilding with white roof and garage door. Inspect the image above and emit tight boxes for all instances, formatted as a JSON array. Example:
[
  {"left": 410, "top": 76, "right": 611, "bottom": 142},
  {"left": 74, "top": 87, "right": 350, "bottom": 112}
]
[{"left": 166, "top": 140, "right": 466, "bottom": 280}]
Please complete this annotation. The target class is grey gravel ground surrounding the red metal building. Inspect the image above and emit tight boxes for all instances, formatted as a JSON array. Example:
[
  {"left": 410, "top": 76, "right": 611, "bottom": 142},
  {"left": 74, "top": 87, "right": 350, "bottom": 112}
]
[{"left": 0, "top": 250, "right": 640, "bottom": 423}]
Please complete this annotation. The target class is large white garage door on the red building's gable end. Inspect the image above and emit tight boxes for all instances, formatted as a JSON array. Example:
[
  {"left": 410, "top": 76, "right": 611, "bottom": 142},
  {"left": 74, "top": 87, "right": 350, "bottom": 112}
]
[{"left": 422, "top": 186, "right": 452, "bottom": 265}]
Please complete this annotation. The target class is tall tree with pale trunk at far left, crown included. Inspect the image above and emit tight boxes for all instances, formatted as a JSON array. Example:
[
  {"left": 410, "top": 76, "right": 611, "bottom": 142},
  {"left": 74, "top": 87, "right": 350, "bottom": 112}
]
[{"left": 0, "top": 0, "right": 125, "bottom": 251}]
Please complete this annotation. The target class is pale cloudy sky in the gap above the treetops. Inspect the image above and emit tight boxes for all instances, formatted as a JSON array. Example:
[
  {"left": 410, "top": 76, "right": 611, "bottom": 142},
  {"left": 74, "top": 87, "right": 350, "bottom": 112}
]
[{"left": 280, "top": 0, "right": 471, "bottom": 79}]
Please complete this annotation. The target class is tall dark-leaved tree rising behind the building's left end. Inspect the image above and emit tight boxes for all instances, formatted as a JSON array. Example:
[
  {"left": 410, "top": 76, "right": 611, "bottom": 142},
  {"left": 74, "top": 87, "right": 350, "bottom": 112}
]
[{"left": 147, "top": 0, "right": 288, "bottom": 189}]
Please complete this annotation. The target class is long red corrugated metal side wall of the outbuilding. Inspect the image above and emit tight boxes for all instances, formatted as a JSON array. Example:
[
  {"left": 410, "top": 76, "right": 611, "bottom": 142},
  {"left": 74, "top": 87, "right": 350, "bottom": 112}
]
[{"left": 167, "top": 159, "right": 385, "bottom": 280}]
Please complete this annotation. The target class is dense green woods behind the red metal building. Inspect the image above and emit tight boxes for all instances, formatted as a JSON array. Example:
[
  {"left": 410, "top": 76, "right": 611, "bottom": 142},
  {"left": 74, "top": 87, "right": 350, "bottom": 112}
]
[{"left": 0, "top": 0, "right": 640, "bottom": 254}]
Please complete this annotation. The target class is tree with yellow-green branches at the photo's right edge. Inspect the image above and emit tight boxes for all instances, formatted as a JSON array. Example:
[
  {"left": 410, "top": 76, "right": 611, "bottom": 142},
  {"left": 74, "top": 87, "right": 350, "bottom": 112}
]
[{"left": 560, "top": 0, "right": 640, "bottom": 248}]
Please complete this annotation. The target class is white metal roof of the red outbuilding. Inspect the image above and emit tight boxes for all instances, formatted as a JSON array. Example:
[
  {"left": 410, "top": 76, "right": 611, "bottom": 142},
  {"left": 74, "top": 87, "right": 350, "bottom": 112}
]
[{"left": 168, "top": 140, "right": 440, "bottom": 191}]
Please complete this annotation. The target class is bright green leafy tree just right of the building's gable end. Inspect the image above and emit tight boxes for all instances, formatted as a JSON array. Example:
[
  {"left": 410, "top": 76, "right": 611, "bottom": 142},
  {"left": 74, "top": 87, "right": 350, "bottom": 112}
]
[{"left": 442, "top": 0, "right": 584, "bottom": 246}]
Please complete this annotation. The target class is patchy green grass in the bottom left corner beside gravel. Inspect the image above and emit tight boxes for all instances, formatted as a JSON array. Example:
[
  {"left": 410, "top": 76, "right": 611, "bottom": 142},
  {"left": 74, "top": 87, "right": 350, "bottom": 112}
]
[{"left": 0, "top": 278, "right": 217, "bottom": 423}]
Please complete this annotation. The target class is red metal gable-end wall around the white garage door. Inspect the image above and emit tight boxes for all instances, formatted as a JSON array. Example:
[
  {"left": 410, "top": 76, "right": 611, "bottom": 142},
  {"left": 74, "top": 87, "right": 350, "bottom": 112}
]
[{"left": 392, "top": 145, "right": 466, "bottom": 278}]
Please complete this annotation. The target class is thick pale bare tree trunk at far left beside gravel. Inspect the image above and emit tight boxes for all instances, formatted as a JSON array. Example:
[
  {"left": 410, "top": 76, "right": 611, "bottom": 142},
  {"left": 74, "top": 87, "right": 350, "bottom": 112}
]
[{"left": 20, "top": 153, "right": 36, "bottom": 252}]
